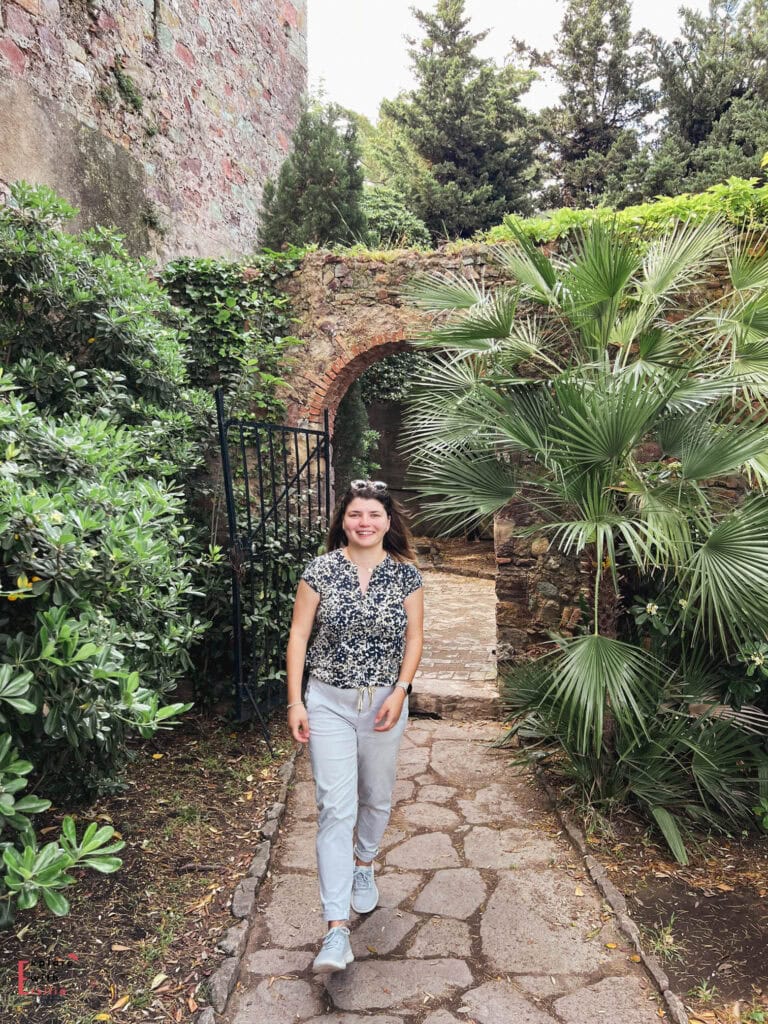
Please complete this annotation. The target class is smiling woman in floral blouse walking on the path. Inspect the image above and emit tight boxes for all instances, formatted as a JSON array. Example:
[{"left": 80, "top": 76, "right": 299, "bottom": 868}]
[{"left": 287, "top": 480, "right": 424, "bottom": 973}]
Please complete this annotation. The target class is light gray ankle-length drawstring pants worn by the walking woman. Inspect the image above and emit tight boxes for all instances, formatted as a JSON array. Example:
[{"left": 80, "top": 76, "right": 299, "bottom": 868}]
[{"left": 305, "top": 676, "right": 408, "bottom": 921}]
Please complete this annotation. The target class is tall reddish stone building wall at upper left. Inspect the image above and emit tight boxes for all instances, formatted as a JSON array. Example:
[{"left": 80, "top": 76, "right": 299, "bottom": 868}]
[{"left": 0, "top": 0, "right": 307, "bottom": 259}]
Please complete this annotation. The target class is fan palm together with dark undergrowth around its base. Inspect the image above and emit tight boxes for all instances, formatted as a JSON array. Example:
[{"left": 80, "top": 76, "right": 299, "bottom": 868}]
[{"left": 407, "top": 220, "right": 768, "bottom": 860}]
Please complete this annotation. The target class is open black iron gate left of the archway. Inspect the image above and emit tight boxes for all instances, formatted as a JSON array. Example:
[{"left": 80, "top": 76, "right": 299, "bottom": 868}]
[{"left": 216, "top": 389, "right": 331, "bottom": 742}]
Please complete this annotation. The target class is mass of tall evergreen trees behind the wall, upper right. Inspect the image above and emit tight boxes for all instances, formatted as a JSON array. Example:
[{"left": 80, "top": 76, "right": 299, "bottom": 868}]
[{"left": 360, "top": 0, "right": 768, "bottom": 227}]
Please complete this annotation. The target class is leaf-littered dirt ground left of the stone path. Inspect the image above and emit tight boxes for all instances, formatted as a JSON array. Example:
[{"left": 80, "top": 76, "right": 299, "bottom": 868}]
[{"left": 0, "top": 715, "right": 293, "bottom": 1024}]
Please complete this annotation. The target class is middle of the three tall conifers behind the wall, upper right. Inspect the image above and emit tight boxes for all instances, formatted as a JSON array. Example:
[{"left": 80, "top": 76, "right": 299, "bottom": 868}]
[{"left": 536, "top": 0, "right": 654, "bottom": 207}]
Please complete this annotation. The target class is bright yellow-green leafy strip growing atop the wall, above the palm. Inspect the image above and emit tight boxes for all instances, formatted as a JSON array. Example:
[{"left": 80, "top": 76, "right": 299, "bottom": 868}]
[{"left": 482, "top": 177, "right": 768, "bottom": 243}]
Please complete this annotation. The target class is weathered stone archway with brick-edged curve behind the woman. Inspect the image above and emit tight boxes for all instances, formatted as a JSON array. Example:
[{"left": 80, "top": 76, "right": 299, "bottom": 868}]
[{"left": 285, "top": 245, "right": 582, "bottom": 667}]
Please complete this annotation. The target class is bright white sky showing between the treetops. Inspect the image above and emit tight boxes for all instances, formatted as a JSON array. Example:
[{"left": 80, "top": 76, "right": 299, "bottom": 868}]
[{"left": 307, "top": 0, "right": 709, "bottom": 121}]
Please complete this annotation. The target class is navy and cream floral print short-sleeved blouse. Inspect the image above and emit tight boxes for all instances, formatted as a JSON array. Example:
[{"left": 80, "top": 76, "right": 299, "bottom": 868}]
[{"left": 301, "top": 548, "right": 423, "bottom": 689}]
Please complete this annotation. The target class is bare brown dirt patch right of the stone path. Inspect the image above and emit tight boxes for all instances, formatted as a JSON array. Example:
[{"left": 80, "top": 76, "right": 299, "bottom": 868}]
[{"left": 552, "top": 798, "right": 768, "bottom": 1024}]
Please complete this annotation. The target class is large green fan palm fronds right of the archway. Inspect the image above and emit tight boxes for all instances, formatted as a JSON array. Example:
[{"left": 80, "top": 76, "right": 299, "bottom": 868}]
[{"left": 404, "top": 220, "right": 768, "bottom": 852}]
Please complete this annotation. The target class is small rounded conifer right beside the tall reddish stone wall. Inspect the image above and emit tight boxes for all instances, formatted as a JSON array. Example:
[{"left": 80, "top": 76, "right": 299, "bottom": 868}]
[{"left": 259, "top": 103, "right": 366, "bottom": 249}]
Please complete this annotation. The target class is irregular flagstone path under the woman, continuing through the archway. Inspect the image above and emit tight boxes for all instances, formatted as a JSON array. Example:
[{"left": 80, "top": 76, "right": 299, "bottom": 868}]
[{"left": 219, "top": 573, "right": 659, "bottom": 1024}]
